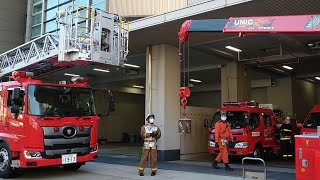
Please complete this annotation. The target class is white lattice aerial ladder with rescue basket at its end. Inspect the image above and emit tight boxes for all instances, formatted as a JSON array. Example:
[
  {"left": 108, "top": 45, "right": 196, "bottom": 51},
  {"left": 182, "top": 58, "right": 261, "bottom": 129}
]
[{"left": 0, "top": 6, "right": 129, "bottom": 78}]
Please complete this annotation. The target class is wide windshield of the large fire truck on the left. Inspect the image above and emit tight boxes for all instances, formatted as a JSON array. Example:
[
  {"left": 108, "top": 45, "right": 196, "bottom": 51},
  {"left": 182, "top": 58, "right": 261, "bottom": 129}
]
[{"left": 28, "top": 85, "right": 95, "bottom": 117}]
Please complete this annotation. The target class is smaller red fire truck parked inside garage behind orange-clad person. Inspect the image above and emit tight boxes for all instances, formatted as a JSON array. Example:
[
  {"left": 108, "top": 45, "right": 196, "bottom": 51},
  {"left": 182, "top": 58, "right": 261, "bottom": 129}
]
[{"left": 208, "top": 101, "right": 280, "bottom": 158}]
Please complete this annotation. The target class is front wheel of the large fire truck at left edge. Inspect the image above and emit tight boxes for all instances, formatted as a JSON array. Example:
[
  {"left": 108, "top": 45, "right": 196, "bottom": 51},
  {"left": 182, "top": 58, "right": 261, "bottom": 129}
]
[{"left": 0, "top": 143, "right": 15, "bottom": 179}]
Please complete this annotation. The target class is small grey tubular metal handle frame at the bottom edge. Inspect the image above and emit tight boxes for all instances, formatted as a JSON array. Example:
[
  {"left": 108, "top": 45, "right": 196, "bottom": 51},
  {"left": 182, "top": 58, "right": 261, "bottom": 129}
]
[{"left": 242, "top": 157, "right": 267, "bottom": 180}]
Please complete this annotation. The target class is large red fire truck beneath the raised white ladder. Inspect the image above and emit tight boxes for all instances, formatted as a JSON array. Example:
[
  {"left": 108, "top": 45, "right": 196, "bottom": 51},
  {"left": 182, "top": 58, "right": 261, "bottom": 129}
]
[{"left": 0, "top": 71, "right": 99, "bottom": 178}]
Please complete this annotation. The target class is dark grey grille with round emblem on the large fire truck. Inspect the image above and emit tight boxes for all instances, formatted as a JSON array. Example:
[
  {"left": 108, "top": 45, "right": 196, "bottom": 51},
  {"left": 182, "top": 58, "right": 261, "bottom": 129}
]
[{"left": 42, "top": 126, "right": 92, "bottom": 159}]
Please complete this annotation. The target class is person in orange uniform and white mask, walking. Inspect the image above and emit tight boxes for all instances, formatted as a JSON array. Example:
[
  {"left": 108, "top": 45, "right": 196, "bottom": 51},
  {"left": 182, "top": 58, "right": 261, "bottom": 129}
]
[{"left": 212, "top": 111, "right": 233, "bottom": 171}]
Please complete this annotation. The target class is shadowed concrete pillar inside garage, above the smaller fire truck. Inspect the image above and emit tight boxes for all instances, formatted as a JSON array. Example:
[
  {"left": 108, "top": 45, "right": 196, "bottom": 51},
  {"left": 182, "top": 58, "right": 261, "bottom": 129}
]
[{"left": 221, "top": 62, "right": 251, "bottom": 103}]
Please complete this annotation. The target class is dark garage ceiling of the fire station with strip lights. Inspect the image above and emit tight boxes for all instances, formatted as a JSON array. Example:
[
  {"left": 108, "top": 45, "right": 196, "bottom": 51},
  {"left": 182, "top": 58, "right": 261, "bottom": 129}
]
[{"left": 45, "top": 0, "right": 320, "bottom": 90}]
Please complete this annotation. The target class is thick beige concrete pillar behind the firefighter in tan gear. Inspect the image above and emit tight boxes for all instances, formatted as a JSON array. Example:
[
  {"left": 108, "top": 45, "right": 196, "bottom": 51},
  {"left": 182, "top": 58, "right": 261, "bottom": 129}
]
[{"left": 145, "top": 44, "right": 180, "bottom": 161}]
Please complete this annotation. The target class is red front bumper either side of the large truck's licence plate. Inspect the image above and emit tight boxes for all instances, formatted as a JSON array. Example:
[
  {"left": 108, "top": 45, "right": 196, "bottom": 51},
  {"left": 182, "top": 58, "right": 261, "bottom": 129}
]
[{"left": 20, "top": 151, "right": 98, "bottom": 168}]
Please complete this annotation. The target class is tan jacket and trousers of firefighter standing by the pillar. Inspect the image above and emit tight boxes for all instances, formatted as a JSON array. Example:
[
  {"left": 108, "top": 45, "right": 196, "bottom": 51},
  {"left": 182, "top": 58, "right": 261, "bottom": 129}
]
[{"left": 139, "top": 124, "right": 161, "bottom": 173}]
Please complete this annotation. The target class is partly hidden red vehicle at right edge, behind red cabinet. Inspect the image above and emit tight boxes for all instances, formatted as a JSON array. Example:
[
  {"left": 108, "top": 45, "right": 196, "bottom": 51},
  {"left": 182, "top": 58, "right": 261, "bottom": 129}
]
[{"left": 298, "top": 104, "right": 320, "bottom": 134}]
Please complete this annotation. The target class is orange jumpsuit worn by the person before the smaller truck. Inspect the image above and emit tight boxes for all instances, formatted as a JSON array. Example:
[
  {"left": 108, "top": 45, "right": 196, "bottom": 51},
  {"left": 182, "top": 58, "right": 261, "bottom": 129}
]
[{"left": 215, "top": 121, "right": 233, "bottom": 164}]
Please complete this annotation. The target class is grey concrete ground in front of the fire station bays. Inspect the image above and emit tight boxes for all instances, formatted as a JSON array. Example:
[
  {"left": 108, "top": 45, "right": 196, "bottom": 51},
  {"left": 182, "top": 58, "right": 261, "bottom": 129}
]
[{"left": 11, "top": 144, "right": 296, "bottom": 180}]
